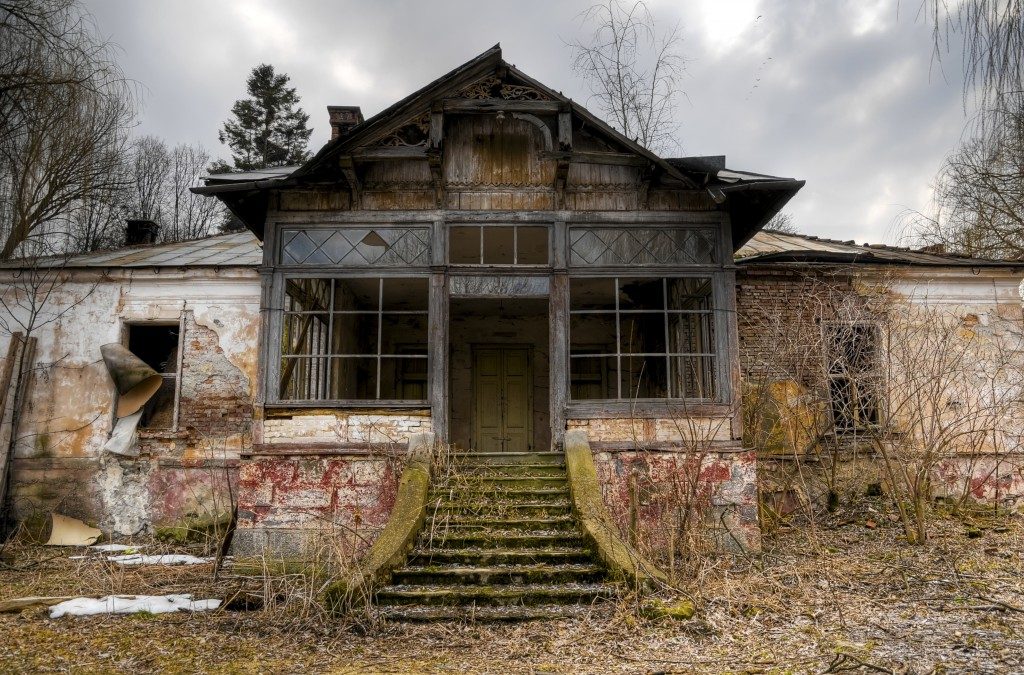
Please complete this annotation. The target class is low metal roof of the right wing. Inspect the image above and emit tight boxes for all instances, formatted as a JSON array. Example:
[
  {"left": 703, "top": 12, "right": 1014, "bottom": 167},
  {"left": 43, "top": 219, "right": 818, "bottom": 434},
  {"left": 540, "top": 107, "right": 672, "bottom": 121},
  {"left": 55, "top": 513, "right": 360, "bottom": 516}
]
[{"left": 735, "top": 229, "right": 1022, "bottom": 267}]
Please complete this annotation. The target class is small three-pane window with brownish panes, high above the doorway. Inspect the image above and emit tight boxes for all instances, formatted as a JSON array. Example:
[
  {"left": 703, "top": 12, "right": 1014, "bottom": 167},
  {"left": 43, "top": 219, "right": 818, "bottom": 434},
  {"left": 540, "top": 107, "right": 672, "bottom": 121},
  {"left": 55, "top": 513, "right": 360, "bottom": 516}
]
[{"left": 449, "top": 225, "right": 548, "bottom": 265}]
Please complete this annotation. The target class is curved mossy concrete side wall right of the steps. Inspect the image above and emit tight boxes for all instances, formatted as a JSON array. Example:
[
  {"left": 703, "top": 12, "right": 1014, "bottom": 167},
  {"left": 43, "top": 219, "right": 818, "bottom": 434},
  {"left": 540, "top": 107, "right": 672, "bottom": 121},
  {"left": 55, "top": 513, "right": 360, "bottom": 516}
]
[{"left": 565, "top": 429, "right": 668, "bottom": 587}]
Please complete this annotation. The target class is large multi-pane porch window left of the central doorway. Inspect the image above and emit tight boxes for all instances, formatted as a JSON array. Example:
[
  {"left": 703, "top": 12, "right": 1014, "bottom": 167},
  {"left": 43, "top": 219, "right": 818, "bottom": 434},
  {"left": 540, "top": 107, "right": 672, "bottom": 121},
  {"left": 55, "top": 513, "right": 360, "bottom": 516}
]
[{"left": 278, "top": 278, "right": 428, "bottom": 402}]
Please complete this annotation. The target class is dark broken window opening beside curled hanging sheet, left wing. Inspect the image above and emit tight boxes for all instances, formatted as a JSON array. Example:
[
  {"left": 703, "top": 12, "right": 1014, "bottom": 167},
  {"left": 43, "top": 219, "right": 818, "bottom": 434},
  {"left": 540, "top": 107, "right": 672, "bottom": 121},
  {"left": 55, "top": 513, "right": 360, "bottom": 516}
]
[{"left": 128, "top": 324, "right": 180, "bottom": 429}]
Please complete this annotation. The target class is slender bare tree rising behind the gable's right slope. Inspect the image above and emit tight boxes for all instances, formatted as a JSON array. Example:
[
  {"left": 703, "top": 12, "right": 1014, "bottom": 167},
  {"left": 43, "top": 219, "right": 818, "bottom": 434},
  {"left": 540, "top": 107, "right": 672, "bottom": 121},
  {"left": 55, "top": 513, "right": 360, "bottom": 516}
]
[{"left": 569, "top": 0, "right": 685, "bottom": 152}]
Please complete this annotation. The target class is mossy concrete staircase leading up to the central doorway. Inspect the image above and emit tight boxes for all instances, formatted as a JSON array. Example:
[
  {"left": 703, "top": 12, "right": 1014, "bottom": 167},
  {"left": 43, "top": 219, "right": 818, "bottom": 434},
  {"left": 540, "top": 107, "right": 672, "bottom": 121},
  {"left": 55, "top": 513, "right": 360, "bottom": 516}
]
[{"left": 376, "top": 452, "right": 616, "bottom": 621}]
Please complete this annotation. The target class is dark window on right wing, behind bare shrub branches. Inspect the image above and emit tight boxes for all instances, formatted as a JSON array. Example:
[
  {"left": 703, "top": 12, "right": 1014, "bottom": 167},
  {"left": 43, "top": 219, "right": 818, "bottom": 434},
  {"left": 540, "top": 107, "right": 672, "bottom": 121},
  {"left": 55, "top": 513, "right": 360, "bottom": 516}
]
[{"left": 823, "top": 324, "right": 879, "bottom": 432}]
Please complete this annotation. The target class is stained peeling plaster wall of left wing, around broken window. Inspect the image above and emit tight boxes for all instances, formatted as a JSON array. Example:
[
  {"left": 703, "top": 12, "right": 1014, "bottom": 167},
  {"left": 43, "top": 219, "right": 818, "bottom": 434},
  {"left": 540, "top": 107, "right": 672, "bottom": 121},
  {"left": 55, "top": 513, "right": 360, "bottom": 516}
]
[{"left": 0, "top": 267, "right": 260, "bottom": 535}]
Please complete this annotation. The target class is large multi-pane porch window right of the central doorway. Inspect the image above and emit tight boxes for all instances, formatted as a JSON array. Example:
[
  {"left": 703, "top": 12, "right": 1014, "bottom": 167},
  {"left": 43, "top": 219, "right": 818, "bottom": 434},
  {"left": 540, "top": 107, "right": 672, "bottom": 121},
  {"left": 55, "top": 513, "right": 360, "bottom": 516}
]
[{"left": 569, "top": 278, "right": 718, "bottom": 400}]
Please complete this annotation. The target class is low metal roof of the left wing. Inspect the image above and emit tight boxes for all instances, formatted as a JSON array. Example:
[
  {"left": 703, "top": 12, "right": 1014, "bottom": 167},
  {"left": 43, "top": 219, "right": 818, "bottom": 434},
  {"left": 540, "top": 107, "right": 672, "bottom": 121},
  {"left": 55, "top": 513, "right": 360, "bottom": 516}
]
[{"left": 0, "top": 230, "right": 263, "bottom": 267}]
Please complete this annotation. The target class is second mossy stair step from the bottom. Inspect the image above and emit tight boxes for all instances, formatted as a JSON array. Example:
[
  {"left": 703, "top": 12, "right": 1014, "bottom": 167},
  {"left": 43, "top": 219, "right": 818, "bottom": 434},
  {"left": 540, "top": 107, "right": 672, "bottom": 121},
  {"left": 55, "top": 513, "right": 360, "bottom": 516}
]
[{"left": 376, "top": 584, "right": 618, "bottom": 606}]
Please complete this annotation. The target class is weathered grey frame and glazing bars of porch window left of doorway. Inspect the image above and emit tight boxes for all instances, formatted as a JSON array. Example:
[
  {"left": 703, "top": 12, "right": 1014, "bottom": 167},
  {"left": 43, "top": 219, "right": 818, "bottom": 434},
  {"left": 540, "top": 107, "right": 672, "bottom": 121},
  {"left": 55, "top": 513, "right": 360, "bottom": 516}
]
[{"left": 264, "top": 268, "right": 433, "bottom": 410}]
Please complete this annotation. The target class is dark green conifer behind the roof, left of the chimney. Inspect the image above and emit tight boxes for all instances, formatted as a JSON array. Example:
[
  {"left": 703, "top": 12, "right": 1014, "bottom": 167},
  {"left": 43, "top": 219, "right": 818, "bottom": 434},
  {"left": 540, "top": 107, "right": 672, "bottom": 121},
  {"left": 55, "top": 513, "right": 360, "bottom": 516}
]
[{"left": 211, "top": 64, "right": 312, "bottom": 172}]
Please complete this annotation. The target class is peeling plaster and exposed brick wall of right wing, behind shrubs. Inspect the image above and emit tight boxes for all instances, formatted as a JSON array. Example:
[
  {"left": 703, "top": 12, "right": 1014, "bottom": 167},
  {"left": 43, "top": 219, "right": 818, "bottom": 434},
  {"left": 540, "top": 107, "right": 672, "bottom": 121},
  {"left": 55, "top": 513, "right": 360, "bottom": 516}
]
[{"left": 737, "top": 265, "right": 1024, "bottom": 508}]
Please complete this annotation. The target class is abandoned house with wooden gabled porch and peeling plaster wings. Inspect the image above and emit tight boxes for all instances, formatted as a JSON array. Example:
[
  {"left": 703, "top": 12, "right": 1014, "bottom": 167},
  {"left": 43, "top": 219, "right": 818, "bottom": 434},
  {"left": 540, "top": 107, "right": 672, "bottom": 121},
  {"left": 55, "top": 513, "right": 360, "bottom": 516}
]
[{"left": 0, "top": 47, "right": 1024, "bottom": 618}]
